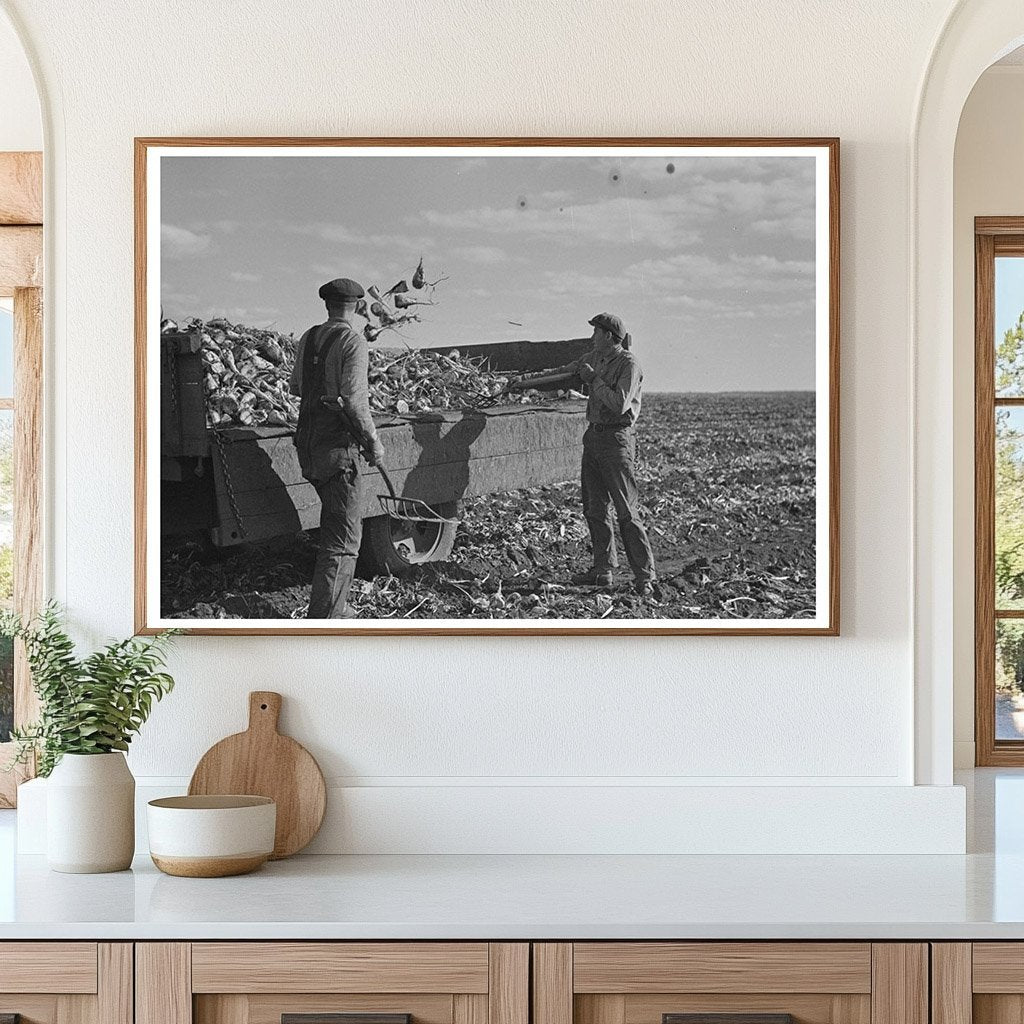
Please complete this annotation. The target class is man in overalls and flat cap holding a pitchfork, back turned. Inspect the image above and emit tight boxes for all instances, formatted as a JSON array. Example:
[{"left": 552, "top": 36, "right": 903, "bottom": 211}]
[{"left": 291, "top": 278, "right": 384, "bottom": 618}]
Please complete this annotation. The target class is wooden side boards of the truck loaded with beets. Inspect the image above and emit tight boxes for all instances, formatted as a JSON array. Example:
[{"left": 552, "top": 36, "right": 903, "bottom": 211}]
[{"left": 161, "top": 335, "right": 589, "bottom": 546}]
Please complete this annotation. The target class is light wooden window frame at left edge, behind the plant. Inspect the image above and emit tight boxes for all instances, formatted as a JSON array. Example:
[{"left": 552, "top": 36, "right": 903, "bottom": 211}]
[{"left": 0, "top": 153, "right": 43, "bottom": 807}]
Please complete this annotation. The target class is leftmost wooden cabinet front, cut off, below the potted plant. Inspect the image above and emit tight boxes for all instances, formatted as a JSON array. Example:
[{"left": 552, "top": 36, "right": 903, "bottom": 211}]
[{"left": 0, "top": 942, "right": 132, "bottom": 1024}]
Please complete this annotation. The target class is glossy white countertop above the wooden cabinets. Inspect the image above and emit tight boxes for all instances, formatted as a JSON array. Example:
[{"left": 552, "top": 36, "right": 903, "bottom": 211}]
[{"left": 0, "top": 770, "right": 1024, "bottom": 940}]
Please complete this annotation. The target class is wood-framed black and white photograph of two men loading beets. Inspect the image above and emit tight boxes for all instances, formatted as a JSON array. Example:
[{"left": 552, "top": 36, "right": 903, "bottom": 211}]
[{"left": 135, "top": 138, "right": 839, "bottom": 635}]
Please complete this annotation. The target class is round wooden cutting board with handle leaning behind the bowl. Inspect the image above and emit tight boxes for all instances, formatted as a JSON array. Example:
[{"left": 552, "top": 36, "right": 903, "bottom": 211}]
[{"left": 188, "top": 690, "right": 327, "bottom": 860}]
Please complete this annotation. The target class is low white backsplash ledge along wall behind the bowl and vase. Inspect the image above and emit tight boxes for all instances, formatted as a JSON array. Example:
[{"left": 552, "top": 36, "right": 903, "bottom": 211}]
[{"left": 17, "top": 779, "right": 967, "bottom": 855}]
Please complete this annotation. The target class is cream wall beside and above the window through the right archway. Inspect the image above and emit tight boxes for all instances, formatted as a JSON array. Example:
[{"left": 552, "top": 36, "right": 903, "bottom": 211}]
[{"left": 953, "top": 65, "right": 1024, "bottom": 767}]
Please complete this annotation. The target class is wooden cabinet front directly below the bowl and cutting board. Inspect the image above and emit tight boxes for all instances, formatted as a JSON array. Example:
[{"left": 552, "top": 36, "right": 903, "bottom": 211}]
[{"left": 136, "top": 942, "right": 529, "bottom": 1024}]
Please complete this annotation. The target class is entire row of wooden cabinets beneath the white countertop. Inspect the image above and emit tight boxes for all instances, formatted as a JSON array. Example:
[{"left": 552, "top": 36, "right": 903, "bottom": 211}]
[{"left": 0, "top": 941, "right": 983, "bottom": 1024}]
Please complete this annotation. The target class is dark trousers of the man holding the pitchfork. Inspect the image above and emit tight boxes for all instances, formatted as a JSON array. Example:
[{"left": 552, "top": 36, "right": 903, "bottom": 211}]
[{"left": 306, "top": 457, "right": 362, "bottom": 618}]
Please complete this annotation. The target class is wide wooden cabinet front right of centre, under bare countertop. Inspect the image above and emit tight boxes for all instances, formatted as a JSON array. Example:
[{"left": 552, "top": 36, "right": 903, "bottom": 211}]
[{"left": 534, "top": 942, "right": 928, "bottom": 1024}]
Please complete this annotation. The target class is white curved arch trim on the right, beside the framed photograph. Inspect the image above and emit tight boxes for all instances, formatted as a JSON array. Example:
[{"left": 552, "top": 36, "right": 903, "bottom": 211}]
[{"left": 909, "top": 0, "right": 1024, "bottom": 785}]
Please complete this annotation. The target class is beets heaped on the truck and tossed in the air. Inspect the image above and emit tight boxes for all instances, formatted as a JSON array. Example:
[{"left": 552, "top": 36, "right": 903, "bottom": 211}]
[{"left": 161, "top": 260, "right": 564, "bottom": 428}]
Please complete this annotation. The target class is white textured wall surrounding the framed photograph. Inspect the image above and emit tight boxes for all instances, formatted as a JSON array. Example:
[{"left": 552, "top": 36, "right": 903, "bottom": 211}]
[{"left": 6, "top": 0, "right": 974, "bottom": 847}]
